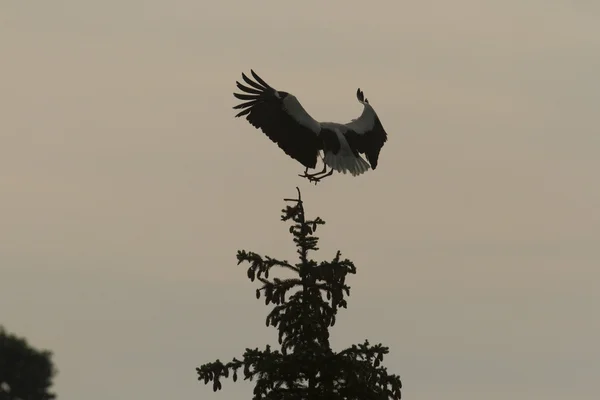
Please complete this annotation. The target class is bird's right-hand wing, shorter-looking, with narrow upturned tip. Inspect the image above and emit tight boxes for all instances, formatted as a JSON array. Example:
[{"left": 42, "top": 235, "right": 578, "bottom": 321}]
[{"left": 344, "top": 89, "right": 387, "bottom": 169}]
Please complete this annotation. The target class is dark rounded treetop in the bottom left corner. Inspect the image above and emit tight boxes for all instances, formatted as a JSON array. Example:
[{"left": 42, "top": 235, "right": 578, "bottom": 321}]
[{"left": 0, "top": 326, "right": 56, "bottom": 400}]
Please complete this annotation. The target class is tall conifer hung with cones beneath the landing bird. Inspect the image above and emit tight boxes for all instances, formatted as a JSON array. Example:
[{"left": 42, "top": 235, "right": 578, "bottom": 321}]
[{"left": 196, "top": 189, "right": 402, "bottom": 400}]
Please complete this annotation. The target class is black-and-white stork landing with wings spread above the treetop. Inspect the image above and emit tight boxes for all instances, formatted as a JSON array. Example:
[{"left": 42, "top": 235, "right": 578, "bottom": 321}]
[{"left": 233, "top": 70, "right": 387, "bottom": 184}]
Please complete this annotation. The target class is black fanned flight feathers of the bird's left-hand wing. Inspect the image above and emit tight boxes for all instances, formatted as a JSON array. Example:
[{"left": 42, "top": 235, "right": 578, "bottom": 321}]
[{"left": 233, "top": 70, "right": 321, "bottom": 168}]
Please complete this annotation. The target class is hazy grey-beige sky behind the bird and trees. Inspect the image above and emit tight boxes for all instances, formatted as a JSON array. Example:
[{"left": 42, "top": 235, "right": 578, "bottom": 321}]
[{"left": 0, "top": 0, "right": 600, "bottom": 400}]
